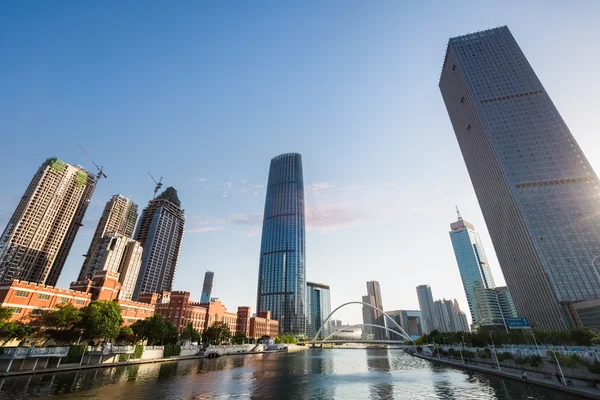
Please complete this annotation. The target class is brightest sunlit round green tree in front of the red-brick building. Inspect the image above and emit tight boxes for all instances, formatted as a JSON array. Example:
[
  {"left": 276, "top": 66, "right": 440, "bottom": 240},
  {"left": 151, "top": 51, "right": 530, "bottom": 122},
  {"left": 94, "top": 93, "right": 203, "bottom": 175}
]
[{"left": 81, "top": 300, "right": 123, "bottom": 339}]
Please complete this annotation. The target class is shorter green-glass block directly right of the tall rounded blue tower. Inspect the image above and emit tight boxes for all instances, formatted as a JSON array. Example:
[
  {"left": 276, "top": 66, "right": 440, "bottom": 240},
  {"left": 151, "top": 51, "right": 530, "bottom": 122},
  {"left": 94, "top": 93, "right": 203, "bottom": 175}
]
[{"left": 306, "top": 282, "right": 333, "bottom": 339}]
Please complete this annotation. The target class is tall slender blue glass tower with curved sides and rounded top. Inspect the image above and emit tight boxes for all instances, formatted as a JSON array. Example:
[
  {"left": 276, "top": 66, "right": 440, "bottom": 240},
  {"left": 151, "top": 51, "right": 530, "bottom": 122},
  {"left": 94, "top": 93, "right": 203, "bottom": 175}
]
[{"left": 256, "top": 153, "right": 306, "bottom": 336}]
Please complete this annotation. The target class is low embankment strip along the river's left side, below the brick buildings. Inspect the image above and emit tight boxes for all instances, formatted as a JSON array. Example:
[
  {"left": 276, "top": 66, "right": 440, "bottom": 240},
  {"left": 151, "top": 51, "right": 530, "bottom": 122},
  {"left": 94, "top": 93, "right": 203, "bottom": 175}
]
[{"left": 0, "top": 346, "right": 290, "bottom": 378}]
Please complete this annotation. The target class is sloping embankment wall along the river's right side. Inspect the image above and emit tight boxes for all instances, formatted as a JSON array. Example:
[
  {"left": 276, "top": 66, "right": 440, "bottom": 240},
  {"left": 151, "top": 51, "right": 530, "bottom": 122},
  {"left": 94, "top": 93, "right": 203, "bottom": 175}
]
[{"left": 407, "top": 352, "right": 600, "bottom": 399}]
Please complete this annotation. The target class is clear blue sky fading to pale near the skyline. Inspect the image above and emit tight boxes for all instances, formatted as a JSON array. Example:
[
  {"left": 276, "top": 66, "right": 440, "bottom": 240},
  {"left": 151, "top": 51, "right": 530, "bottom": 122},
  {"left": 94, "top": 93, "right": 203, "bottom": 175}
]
[{"left": 0, "top": 1, "right": 600, "bottom": 323}]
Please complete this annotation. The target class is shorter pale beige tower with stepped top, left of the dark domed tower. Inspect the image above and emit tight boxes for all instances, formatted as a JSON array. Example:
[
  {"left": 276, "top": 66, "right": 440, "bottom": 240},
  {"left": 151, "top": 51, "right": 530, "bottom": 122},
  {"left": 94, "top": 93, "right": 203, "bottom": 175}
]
[{"left": 78, "top": 233, "right": 143, "bottom": 300}]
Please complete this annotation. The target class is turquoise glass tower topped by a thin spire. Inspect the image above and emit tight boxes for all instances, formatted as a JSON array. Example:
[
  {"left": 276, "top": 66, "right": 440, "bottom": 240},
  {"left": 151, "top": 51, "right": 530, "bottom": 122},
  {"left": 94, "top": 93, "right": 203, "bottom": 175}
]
[{"left": 450, "top": 208, "right": 496, "bottom": 325}]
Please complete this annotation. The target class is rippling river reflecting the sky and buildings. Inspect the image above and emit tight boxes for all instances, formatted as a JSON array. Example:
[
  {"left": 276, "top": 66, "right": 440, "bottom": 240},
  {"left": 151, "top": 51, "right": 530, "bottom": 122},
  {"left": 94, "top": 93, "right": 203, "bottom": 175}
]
[{"left": 0, "top": 349, "right": 582, "bottom": 400}]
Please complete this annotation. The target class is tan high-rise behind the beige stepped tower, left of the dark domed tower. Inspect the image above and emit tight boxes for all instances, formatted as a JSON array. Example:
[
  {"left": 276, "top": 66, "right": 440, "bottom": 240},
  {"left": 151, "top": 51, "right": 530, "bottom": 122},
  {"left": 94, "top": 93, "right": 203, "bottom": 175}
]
[{"left": 77, "top": 194, "right": 138, "bottom": 280}]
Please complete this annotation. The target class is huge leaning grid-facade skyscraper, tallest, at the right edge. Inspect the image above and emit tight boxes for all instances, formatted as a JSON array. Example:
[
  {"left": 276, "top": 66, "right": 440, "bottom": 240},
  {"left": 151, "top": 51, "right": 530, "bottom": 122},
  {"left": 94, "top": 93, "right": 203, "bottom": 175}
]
[{"left": 439, "top": 26, "right": 600, "bottom": 330}]
